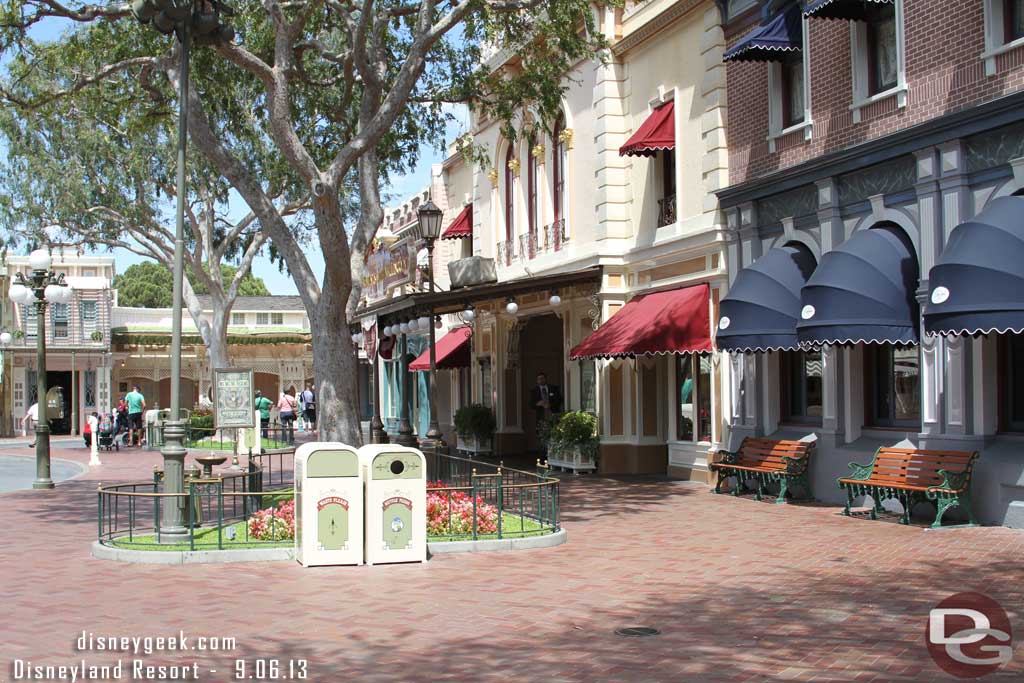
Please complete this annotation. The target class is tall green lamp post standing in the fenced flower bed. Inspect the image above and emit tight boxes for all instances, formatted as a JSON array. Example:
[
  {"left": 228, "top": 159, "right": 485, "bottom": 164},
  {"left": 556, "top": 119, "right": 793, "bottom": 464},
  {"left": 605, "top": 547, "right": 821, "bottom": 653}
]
[{"left": 131, "top": 0, "right": 234, "bottom": 543}]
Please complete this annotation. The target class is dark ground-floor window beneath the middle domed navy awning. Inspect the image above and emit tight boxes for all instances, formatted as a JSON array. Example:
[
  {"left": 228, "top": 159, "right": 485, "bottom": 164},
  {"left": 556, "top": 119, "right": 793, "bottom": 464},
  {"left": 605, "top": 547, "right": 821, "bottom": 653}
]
[{"left": 864, "top": 344, "right": 921, "bottom": 429}]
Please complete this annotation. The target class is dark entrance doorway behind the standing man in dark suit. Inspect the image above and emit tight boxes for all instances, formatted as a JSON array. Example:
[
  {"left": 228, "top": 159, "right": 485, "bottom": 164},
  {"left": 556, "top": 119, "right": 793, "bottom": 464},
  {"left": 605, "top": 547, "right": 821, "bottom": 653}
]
[{"left": 519, "top": 314, "right": 565, "bottom": 454}]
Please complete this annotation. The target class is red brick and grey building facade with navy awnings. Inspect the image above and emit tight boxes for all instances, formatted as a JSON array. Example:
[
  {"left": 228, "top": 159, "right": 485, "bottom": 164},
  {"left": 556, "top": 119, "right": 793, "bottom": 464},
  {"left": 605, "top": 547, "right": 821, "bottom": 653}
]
[{"left": 718, "top": 0, "right": 1024, "bottom": 526}]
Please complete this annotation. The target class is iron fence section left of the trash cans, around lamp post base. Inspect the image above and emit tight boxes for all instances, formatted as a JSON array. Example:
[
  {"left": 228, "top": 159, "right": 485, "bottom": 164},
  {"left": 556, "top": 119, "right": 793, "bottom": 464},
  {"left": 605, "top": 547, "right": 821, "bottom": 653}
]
[{"left": 96, "top": 454, "right": 295, "bottom": 550}]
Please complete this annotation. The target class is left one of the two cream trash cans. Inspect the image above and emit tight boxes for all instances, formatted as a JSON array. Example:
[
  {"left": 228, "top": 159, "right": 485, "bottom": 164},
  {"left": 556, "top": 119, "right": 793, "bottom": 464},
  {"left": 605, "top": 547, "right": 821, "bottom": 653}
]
[{"left": 295, "top": 443, "right": 364, "bottom": 566}]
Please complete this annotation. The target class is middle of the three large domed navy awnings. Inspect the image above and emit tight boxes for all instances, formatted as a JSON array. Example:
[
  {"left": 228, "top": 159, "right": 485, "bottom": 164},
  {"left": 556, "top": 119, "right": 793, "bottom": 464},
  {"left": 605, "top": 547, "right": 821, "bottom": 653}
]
[{"left": 797, "top": 227, "right": 919, "bottom": 347}]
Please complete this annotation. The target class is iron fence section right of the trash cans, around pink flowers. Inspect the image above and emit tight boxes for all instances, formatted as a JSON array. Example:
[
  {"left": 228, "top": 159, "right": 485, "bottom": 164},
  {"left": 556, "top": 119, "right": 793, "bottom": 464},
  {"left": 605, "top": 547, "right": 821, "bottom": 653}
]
[{"left": 425, "top": 452, "right": 560, "bottom": 541}]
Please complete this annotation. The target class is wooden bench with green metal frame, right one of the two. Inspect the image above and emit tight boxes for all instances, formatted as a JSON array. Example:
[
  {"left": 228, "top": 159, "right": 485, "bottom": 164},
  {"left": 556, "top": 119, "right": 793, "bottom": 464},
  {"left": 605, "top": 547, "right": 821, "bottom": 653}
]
[{"left": 836, "top": 447, "right": 978, "bottom": 528}]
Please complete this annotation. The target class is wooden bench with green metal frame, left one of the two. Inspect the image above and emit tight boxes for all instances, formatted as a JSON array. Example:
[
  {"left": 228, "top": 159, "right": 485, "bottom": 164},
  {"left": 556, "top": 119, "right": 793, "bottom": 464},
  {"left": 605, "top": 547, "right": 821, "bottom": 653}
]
[{"left": 708, "top": 436, "right": 814, "bottom": 503}]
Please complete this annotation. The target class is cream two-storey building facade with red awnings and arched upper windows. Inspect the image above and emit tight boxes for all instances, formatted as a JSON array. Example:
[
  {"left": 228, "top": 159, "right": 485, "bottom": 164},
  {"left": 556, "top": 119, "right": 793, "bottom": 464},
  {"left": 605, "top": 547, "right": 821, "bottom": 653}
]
[{"left": 360, "top": 0, "right": 729, "bottom": 479}]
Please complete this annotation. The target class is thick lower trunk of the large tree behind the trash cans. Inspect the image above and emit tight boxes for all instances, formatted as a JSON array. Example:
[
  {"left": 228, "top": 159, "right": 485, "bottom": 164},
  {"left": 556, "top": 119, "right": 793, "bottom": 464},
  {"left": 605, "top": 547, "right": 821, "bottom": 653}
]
[{"left": 309, "top": 289, "right": 362, "bottom": 446}]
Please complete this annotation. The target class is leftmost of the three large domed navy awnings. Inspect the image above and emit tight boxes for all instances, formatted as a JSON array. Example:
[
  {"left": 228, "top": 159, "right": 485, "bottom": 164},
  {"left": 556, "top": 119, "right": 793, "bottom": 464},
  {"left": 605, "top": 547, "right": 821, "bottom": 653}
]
[{"left": 715, "top": 247, "right": 815, "bottom": 351}]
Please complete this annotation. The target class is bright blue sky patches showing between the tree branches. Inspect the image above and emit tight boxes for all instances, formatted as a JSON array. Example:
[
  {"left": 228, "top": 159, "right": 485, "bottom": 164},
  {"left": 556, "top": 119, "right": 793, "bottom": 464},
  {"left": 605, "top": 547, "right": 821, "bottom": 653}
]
[{"left": 12, "top": 13, "right": 469, "bottom": 294}]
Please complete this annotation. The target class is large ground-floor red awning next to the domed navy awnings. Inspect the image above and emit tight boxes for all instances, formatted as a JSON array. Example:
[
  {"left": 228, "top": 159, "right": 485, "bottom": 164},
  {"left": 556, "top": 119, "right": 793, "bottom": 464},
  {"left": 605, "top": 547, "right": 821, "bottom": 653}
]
[{"left": 569, "top": 284, "right": 712, "bottom": 360}]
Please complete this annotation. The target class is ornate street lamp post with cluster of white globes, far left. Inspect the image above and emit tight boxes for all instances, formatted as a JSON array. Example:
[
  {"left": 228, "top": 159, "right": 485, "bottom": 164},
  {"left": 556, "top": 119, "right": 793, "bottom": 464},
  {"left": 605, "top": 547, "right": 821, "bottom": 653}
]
[{"left": 4, "top": 249, "right": 72, "bottom": 488}]
